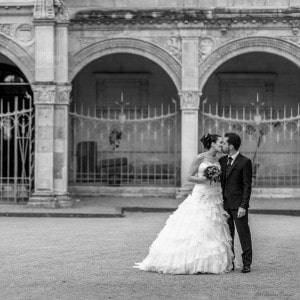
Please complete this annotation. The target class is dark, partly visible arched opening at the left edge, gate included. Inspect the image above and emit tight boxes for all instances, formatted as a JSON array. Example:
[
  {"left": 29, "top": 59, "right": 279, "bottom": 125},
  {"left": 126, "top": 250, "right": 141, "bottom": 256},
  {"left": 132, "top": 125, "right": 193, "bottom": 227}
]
[{"left": 0, "top": 54, "right": 34, "bottom": 203}]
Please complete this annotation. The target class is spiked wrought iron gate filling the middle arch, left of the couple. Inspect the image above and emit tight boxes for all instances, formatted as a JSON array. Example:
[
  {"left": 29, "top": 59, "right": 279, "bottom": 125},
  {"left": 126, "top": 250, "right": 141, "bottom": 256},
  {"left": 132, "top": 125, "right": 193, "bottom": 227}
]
[{"left": 69, "top": 101, "right": 180, "bottom": 186}]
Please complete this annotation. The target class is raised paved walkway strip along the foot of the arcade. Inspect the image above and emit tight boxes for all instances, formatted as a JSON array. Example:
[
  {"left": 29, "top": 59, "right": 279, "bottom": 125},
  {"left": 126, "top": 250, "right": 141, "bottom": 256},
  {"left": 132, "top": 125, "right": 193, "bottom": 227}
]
[{"left": 0, "top": 196, "right": 300, "bottom": 218}]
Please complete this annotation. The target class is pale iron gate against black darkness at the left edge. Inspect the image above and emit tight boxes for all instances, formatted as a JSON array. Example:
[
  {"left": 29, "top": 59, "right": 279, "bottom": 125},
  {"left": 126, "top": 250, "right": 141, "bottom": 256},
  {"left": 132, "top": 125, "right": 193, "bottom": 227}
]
[{"left": 0, "top": 94, "right": 34, "bottom": 203}]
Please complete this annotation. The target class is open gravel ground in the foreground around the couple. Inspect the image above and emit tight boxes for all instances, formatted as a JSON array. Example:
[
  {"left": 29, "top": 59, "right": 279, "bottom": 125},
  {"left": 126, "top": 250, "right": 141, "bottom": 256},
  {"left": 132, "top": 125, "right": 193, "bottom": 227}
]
[{"left": 0, "top": 213, "right": 300, "bottom": 300}]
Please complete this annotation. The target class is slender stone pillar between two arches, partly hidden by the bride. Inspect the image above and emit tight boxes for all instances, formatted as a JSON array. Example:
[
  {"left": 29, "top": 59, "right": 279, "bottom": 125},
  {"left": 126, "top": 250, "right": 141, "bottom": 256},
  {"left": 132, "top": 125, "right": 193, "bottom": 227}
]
[{"left": 177, "top": 32, "right": 201, "bottom": 197}]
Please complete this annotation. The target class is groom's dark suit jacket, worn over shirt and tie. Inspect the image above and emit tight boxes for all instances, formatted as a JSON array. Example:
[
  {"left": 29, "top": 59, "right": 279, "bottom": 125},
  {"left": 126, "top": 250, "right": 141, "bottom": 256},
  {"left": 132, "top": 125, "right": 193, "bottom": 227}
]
[{"left": 219, "top": 153, "right": 252, "bottom": 209}]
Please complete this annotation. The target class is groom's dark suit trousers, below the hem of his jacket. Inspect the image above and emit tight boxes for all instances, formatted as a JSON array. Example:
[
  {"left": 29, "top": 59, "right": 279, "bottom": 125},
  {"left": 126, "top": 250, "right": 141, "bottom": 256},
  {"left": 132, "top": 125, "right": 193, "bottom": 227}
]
[{"left": 225, "top": 203, "right": 252, "bottom": 266}]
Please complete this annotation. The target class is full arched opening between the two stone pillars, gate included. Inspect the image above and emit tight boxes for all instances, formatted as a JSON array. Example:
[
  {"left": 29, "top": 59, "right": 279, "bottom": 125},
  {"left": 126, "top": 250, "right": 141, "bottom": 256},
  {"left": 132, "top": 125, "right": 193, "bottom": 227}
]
[{"left": 69, "top": 53, "right": 180, "bottom": 187}]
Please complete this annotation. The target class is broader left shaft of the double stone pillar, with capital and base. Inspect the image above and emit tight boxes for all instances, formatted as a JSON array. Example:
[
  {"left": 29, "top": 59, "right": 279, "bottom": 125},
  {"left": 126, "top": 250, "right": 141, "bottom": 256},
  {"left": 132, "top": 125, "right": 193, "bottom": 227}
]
[{"left": 28, "top": 6, "right": 56, "bottom": 207}]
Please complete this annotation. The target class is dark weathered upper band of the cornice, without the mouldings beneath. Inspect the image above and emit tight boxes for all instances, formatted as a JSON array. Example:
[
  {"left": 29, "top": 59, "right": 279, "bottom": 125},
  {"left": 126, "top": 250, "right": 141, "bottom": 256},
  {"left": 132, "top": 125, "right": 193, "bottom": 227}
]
[{"left": 71, "top": 8, "right": 300, "bottom": 25}]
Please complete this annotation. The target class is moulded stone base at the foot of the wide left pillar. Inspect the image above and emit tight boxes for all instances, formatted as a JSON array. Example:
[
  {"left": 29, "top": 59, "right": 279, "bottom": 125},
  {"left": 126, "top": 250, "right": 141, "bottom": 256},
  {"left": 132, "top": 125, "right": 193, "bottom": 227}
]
[{"left": 27, "top": 195, "right": 72, "bottom": 208}]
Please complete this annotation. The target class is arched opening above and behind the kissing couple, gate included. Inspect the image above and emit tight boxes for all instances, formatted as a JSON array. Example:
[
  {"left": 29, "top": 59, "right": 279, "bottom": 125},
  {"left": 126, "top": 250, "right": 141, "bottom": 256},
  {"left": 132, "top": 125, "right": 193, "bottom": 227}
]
[{"left": 199, "top": 52, "right": 300, "bottom": 187}]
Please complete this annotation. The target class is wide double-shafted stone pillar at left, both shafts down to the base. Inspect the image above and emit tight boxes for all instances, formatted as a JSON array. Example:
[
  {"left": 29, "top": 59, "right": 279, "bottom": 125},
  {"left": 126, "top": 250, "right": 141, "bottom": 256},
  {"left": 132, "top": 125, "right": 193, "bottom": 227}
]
[{"left": 28, "top": 0, "right": 71, "bottom": 207}]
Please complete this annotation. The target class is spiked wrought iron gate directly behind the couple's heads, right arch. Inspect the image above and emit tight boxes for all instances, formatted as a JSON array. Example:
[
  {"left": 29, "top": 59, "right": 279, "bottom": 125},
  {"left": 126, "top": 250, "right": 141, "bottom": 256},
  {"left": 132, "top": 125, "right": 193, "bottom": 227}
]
[{"left": 199, "top": 101, "right": 300, "bottom": 187}]
